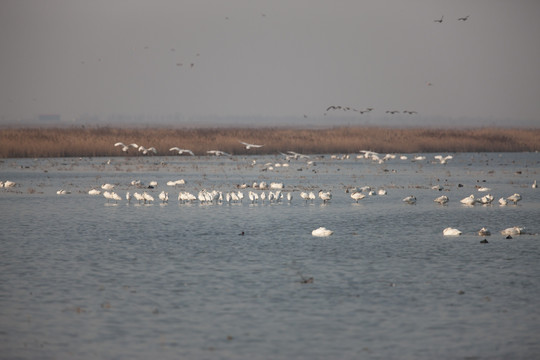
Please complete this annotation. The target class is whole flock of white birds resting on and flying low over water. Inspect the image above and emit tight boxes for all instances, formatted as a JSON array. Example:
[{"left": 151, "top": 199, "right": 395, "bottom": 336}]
[{"left": 4, "top": 148, "right": 537, "bottom": 236}]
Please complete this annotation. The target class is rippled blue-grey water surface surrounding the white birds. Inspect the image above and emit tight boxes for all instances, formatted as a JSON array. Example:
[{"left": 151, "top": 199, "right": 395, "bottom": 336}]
[{"left": 0, "top": 153, "right": 540, "bottom": 359}]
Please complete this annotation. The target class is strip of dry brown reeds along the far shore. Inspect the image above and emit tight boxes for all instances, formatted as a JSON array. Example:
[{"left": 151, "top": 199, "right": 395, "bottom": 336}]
[{"left": 0, "top": 127, "right": 540, "bottom": 158}]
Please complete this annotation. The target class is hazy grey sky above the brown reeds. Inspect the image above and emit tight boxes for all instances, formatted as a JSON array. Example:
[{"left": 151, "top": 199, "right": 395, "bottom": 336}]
[{"left": 0, "top": 0, "right": 540, "bottom": 127}]
